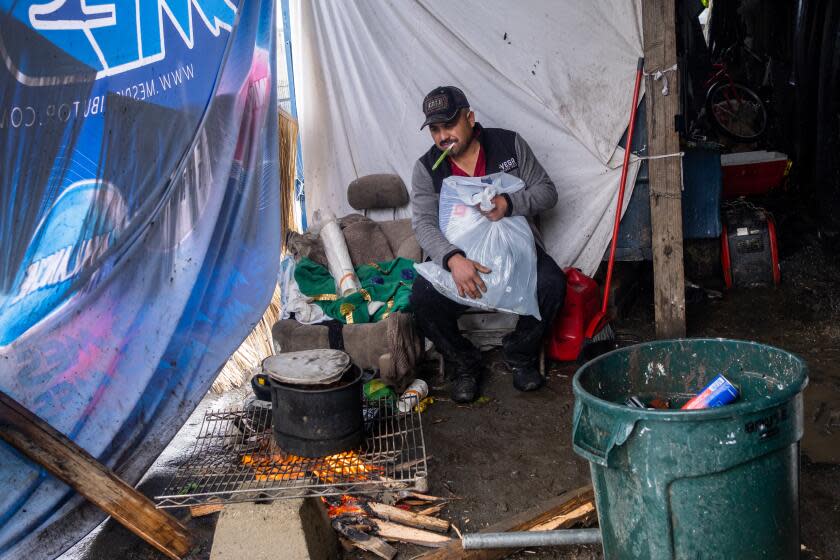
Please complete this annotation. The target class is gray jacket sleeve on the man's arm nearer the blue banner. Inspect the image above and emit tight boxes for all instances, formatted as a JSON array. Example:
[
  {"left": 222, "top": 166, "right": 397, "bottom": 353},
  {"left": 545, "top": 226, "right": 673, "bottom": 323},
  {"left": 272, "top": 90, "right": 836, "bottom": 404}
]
[{"left": 411, "top": 161, "right": 464, "bottom": 270}]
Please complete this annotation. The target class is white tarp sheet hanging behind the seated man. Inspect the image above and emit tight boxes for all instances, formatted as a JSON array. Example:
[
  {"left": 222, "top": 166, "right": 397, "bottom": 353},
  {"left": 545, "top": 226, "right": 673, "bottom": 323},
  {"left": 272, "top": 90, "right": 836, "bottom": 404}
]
[{"left": 290, "top": 0, "right": 642, "bottom": 274}]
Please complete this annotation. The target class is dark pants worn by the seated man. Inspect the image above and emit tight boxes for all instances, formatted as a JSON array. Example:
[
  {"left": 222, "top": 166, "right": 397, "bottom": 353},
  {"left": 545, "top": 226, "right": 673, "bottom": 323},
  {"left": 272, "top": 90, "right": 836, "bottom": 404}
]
[{"left": 411, "top": 247, "right": 566, "bottom": 371}]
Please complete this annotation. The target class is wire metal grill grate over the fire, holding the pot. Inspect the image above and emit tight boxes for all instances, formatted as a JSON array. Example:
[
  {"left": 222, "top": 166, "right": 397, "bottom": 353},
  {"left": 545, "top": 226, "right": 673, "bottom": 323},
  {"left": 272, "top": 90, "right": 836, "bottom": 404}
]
[{"left": 155, "top": 400, "right": 427, "bottom": 508}]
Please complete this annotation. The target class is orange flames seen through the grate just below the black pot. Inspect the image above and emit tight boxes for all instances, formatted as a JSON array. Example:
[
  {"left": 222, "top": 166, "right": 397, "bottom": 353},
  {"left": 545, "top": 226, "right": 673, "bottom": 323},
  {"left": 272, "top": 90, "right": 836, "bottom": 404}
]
[{"left": 242, "top": 451, "right": 382, "bottom": 484}]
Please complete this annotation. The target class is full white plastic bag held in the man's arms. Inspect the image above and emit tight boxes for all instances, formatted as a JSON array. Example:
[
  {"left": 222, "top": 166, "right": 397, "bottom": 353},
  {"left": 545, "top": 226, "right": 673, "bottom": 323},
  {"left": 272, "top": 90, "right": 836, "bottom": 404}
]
[{"left": 414, "top": 173, "right": 541, "bottom": 319}]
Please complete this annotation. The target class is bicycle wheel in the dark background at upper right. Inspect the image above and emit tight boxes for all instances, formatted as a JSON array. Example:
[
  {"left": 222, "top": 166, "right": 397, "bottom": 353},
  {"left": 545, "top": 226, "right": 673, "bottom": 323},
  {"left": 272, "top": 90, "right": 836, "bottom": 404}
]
[{"left": 706, "top": 82, "right": 767, "bottom": 142}]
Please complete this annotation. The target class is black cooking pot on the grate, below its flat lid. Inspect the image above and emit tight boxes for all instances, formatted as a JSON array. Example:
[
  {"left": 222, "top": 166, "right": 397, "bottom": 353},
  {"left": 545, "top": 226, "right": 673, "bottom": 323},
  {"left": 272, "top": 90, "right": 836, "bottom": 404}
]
[{"left": 252, "top": 365, "right": 365, "bottom": 457}]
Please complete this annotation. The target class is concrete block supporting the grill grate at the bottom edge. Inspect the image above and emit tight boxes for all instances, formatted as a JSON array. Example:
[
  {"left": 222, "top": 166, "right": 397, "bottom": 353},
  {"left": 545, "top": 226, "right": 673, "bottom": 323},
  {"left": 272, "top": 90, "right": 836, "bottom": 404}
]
[{"left": 210, "top": 498, "right": 339, "bottom": 560}]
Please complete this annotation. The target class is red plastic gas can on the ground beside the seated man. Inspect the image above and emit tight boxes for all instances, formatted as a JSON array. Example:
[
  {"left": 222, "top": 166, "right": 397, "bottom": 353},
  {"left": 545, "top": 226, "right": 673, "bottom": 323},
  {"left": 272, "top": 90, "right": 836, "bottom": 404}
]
[{"left": 545, "top": 268, "right": 601, "bottom": 362}]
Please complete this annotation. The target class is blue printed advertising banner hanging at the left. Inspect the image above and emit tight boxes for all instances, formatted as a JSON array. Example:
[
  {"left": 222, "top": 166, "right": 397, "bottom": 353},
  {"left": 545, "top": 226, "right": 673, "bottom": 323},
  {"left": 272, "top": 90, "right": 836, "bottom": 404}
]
[{"left": 0, "top": 0, "right": 280, "bottom": 559}]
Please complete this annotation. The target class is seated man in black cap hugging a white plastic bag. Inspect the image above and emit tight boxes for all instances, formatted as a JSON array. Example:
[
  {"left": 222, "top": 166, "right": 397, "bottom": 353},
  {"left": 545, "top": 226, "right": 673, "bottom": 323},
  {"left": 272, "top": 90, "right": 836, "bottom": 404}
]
[{"left": 411, "top": 86, "right": 566, "bottom": 402}]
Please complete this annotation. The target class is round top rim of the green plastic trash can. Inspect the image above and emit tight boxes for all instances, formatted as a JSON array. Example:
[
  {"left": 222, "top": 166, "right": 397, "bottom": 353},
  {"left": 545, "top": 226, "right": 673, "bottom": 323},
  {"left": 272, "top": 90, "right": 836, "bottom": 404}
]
[{"left": 572, "top": 337, "right": 808, "bottom": 422}]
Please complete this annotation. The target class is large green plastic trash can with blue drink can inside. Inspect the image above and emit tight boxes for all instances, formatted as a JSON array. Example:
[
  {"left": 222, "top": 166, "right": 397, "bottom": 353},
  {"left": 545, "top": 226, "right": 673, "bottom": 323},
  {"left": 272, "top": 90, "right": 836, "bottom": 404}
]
[{"left": 573, "top": 339, "right": 808, "bottom": 560}]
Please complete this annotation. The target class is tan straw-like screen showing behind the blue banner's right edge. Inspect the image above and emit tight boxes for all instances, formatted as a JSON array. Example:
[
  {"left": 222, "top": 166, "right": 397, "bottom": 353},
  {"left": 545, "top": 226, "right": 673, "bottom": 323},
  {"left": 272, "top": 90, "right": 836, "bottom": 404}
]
[{"left": 210, "top": 111, "right": 298, "bottom": 394}]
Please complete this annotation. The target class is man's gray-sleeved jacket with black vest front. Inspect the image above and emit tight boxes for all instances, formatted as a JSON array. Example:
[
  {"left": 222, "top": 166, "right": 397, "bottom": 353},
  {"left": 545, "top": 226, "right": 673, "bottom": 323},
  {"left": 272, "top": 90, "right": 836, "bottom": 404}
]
[{"left": 411, "top": 123, "right": 557, "bottom": 270}]
